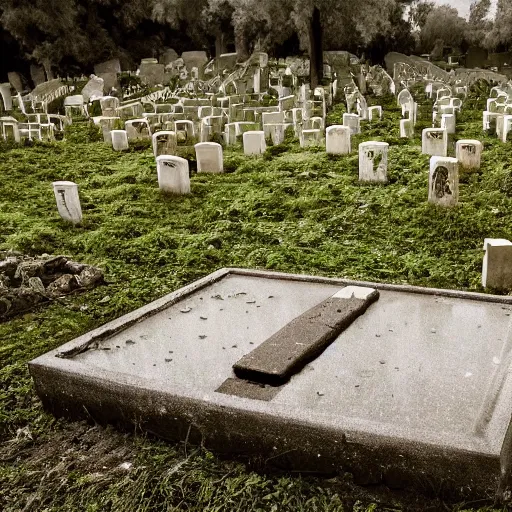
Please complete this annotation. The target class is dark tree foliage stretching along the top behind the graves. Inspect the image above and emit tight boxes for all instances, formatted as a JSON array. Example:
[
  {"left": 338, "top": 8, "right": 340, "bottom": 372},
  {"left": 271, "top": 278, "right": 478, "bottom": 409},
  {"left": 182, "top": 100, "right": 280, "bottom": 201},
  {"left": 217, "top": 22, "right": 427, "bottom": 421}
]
[{"left": 0, "top": 0, "right": 512, "bottom": 83}]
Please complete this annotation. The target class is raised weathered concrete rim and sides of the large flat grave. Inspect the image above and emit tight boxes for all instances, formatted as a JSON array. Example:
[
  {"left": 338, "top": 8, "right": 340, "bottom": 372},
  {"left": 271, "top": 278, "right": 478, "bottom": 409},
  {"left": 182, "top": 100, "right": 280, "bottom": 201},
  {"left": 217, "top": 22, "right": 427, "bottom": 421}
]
[{"left": 29, "top": 268, "right": 512, "bottom": 499}]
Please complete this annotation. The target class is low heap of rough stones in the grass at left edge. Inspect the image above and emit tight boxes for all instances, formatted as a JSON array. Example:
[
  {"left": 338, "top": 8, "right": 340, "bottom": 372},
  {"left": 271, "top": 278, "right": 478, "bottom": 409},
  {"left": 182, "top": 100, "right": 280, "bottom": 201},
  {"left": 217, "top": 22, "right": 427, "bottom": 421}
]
[{"left": 0, "top": 251, "right": 103, "bottom": 322}]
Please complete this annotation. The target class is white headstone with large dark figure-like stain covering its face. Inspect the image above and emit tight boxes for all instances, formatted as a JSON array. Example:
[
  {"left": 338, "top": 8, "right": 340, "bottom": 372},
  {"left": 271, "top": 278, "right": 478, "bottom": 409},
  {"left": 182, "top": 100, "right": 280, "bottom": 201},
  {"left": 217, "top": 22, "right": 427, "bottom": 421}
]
[{"left": 428, "top": 156, "right": 459, "bottom": 206}]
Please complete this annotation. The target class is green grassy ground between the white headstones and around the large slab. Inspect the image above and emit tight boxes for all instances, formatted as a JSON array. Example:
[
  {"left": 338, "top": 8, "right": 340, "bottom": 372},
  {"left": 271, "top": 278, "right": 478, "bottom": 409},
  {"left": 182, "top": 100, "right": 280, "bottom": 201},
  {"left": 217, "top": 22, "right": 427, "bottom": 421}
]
[{"left": 0, "top": 90, "right": 512, "bottom": 512}]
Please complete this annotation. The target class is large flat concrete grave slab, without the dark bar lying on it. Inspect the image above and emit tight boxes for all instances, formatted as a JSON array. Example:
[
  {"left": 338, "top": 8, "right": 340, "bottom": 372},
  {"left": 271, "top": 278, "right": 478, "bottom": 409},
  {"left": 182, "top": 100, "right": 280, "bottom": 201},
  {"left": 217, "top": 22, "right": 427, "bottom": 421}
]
[{"left": 30, "top": 271, "right": 512, "bottom": 497}]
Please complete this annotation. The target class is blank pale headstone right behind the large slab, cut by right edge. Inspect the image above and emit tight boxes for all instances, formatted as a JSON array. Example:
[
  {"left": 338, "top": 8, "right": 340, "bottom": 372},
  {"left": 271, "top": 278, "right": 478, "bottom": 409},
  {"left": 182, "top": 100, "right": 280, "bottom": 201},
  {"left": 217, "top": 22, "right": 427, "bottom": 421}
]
[{"left": 482, "top": 238, "right": 512, "bottom": 290}]
